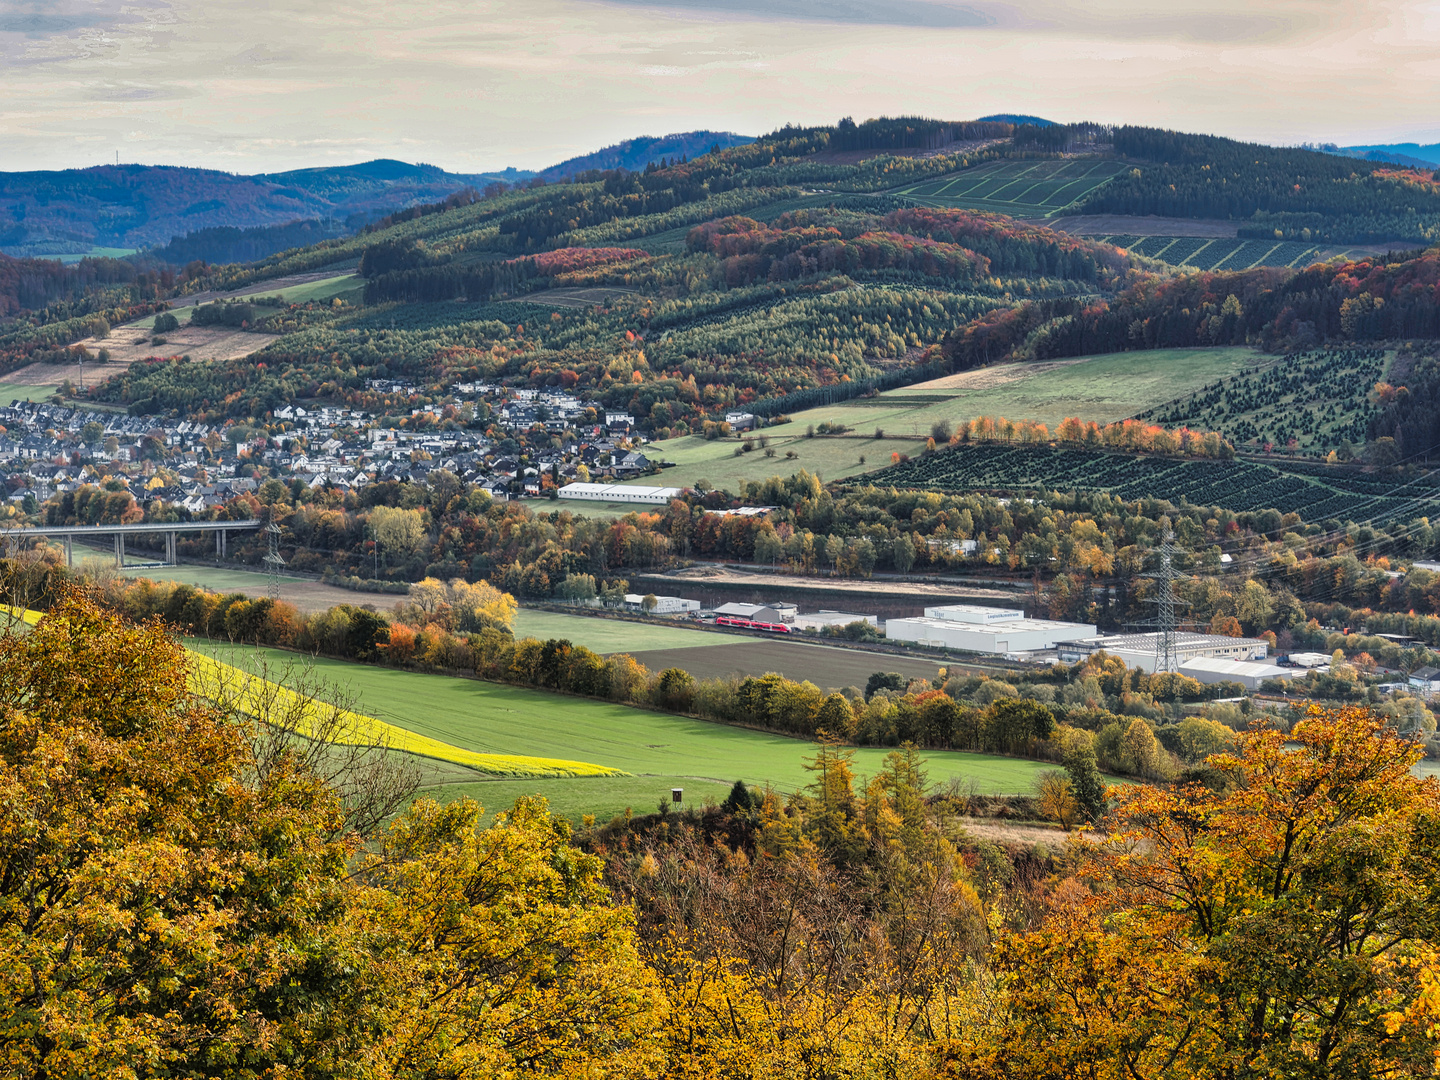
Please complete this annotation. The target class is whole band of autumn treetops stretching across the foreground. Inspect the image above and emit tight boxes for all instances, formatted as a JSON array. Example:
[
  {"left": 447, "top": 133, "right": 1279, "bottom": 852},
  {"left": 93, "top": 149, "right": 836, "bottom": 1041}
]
[{"left": 0, "top": 593, "right": 1440, "bottom": 1080}]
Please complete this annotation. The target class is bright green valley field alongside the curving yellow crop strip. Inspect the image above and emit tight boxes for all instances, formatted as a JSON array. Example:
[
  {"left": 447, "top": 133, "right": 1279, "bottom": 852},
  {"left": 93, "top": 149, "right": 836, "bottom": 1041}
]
[{"left": 190, "top": 641, "right": 1048, "bottom": 815}]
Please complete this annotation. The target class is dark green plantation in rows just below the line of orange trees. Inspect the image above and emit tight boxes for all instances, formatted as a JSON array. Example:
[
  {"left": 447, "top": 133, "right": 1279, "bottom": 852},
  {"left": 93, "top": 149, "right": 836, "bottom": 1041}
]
[{"left": 867, "top": 444, "right": 1440, "bottom": 523}]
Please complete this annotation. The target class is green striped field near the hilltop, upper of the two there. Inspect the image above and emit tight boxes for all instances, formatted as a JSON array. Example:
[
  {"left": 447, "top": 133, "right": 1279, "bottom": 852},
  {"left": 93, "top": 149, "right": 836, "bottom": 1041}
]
[{"left": 893, "top": 158, "right": 1125, "bottom": 217}]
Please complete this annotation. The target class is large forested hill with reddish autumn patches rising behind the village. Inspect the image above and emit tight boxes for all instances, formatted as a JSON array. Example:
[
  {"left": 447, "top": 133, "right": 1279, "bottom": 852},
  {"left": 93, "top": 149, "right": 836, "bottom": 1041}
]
[{"left": 11, "top": 118, "right": 1440, "bottom": 438}]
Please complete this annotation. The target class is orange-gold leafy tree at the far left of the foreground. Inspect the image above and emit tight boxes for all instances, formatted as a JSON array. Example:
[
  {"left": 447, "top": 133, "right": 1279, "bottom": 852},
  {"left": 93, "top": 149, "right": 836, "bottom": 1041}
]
[{"left": 0, "top": 596, "right": 353, "bottom": 1077}]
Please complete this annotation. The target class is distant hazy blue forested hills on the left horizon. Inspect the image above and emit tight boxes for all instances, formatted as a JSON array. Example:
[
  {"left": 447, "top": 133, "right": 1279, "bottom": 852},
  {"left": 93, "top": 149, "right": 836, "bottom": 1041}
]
[{"left": 0, "top": 161, "right": 523, "bottom": 255}]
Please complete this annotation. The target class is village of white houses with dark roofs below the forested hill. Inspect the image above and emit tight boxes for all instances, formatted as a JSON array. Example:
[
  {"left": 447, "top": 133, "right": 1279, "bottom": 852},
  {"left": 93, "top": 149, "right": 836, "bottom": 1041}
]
[{"left": 0, "top": 380, "right": 657, "bottom": 520}]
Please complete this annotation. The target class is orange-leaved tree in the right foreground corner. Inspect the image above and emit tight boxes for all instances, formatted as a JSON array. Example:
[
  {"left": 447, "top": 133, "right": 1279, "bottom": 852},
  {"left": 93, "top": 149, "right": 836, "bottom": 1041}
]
[{"left": 991, "top": 708, "right": 1440, "bottom": 1080}]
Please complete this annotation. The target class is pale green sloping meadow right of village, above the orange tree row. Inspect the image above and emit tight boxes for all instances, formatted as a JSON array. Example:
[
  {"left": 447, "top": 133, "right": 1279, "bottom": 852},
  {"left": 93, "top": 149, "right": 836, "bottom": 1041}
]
[{"left": 635, "top": 348, "right": 1273, "bottom": 490}]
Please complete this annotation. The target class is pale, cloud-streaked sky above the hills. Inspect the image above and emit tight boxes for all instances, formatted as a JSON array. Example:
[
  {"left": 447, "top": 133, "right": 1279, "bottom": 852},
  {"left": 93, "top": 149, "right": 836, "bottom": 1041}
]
[{"left": 0, "top": 0, "right": 1440, "bottom": 173}]
